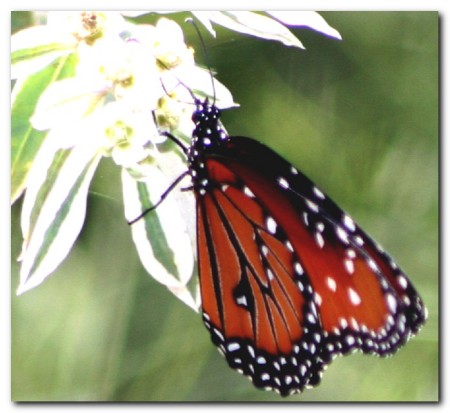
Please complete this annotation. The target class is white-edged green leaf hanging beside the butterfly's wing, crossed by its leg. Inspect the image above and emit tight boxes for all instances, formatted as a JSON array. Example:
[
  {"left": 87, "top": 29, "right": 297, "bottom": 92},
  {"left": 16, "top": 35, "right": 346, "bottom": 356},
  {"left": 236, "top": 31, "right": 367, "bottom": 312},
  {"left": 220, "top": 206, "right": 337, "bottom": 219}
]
[{"left": 122, "top": 167, "right": 199, "bottom": 310}]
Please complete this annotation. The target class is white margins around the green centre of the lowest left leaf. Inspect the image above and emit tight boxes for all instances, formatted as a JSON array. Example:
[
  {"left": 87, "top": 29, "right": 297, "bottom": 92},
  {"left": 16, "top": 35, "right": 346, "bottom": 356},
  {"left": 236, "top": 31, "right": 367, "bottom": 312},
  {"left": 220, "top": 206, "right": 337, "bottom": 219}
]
[{"left": 17, "top": 141, "right": 101, "bottom": 295}]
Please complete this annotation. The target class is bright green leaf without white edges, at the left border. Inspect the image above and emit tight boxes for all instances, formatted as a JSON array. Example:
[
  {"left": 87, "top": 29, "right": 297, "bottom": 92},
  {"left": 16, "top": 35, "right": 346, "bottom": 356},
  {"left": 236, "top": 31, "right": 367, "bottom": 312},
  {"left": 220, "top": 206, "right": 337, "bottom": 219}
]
[{"left": 11, "top": 55, "right": 76, "bottom": 203}]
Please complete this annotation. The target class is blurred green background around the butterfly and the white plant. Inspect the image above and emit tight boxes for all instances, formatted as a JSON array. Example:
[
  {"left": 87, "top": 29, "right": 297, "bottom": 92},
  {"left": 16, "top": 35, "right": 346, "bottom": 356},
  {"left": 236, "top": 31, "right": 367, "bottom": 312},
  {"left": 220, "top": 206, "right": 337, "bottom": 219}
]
[{"left": 11, "top": 12, "right": 439, "bottom": 402}]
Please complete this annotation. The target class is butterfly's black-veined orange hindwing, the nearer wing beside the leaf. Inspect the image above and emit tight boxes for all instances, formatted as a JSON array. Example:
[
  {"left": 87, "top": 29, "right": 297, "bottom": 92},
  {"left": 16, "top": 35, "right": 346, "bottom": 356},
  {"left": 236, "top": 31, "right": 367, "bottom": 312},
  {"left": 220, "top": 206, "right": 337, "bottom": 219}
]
[{"left": 198, "top": 161, "right": 322, "bottom": 395}]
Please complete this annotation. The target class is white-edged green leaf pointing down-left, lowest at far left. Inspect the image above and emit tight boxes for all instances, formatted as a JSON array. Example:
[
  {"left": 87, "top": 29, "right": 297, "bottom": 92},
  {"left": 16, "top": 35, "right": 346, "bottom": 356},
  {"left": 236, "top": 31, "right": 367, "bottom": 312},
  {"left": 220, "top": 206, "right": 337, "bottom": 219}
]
[{"left": 17, "top": 146, "right": 101, "bottom": 294}]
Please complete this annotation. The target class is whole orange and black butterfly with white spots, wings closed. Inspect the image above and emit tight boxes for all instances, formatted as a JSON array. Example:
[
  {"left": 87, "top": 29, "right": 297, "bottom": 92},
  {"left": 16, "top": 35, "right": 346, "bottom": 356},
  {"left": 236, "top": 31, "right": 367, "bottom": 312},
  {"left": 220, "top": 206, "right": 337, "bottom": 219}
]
[{"left": 136, "top": 98, "right": 426, "bottom": 396}]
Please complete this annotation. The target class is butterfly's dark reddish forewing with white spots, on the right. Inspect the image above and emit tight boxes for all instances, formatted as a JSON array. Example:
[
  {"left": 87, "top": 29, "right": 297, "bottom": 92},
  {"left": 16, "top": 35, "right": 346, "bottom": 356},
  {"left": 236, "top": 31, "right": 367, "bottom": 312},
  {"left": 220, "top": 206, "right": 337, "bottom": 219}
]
[{"left": 218, "top": 137, "right": 425, "bottom": 355}]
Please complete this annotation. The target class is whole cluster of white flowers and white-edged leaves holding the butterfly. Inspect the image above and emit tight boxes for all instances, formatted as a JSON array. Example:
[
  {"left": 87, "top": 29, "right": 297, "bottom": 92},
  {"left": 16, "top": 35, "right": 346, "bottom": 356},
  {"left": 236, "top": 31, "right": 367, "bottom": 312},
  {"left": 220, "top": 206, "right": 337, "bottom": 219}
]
[{"left": 11, "top": 11, "right": 339, "bottom": 309}]
